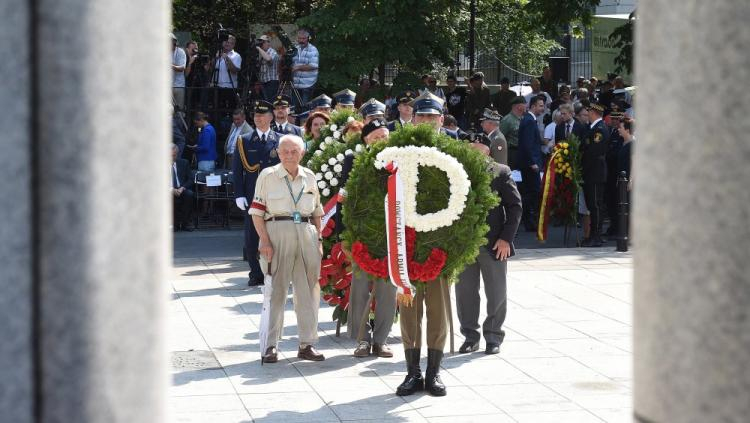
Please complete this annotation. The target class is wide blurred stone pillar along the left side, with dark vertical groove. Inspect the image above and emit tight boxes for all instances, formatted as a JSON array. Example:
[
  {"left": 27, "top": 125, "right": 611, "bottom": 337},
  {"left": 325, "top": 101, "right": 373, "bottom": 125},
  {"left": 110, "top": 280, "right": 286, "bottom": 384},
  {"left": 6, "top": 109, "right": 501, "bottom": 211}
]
[{"left": 0, "top": 0, "right": 171, "bottom": 423}]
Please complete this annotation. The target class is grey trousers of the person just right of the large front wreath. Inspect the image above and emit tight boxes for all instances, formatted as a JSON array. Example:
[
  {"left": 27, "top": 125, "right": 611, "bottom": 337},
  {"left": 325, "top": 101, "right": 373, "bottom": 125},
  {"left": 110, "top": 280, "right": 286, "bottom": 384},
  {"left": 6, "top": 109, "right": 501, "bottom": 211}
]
[{"left": 456, "top": 247, "right": 508, "bottom": 344}]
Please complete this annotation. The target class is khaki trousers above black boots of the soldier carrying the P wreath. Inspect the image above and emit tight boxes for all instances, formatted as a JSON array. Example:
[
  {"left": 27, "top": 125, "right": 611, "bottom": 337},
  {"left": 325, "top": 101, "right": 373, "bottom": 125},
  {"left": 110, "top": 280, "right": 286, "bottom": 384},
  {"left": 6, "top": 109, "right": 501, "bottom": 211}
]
[{"left": 399, "top": 280, "right": 450, "bottom": 351}]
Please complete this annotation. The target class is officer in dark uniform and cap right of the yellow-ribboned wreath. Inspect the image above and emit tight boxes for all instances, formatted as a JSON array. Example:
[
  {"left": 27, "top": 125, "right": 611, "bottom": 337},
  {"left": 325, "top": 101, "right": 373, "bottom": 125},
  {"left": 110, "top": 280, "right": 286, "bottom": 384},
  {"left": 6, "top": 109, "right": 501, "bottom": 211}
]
[{"left": 581, "top": 104, "right": 609, "bottom": 247}]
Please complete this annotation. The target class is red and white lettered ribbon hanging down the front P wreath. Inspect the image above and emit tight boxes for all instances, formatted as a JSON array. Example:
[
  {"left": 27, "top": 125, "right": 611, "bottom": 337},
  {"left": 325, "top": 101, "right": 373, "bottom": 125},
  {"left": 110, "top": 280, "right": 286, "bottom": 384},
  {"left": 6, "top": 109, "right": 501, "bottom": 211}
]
[{"left": 385, "top": 162, "right": 414, "bottom": 299}]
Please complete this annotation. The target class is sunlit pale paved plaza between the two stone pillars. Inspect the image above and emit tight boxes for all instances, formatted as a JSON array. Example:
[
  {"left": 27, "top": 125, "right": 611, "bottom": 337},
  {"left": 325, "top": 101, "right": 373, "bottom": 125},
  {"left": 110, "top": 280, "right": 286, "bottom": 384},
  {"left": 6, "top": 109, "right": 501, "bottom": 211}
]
[{"left": 168, "top": 247, "right": 632, "bottom": 423}]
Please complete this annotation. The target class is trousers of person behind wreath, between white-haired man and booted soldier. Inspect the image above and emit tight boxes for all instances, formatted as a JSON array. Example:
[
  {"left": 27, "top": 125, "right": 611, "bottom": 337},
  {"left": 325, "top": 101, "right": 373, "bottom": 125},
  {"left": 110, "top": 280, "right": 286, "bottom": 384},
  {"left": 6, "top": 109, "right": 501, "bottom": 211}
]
[{"left": 346, "top": 272, "right": 396, "bottom": 345}]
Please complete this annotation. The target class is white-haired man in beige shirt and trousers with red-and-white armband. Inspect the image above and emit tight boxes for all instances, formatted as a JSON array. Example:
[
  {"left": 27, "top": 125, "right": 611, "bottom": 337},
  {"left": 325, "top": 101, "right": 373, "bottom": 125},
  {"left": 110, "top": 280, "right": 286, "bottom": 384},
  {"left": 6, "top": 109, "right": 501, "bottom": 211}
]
[{"left": 249, "top": 135, "right": 325, "bottom": 363}]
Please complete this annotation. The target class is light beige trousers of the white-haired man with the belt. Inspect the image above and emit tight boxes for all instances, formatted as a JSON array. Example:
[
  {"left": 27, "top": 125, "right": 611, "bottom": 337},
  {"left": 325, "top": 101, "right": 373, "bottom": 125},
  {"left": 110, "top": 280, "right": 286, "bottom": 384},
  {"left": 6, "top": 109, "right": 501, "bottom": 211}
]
[{"left": 260, "top": 221, "right": 321, "bottom": 347}]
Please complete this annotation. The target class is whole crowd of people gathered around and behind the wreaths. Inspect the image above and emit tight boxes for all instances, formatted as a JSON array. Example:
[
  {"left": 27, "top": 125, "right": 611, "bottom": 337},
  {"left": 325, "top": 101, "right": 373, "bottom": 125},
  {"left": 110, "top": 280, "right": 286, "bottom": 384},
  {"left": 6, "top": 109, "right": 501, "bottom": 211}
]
[{"left": 172, "top": 31, "right": 634, "bottom": 396}]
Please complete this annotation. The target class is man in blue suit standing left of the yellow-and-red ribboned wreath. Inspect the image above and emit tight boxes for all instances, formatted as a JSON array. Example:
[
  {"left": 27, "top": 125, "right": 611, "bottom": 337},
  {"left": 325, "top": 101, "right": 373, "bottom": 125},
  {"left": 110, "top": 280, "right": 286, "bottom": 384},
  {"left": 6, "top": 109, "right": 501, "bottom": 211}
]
[{"left": 516, "top": 97, "right": 544, "bottom": 232}]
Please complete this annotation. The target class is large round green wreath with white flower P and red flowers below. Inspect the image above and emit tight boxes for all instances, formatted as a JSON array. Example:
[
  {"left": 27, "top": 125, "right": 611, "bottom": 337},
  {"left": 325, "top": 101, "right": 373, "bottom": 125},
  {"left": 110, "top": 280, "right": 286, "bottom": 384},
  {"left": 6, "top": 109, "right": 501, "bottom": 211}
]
[{"left": 344, "top": 125, "right": 498, "bottom": 282}]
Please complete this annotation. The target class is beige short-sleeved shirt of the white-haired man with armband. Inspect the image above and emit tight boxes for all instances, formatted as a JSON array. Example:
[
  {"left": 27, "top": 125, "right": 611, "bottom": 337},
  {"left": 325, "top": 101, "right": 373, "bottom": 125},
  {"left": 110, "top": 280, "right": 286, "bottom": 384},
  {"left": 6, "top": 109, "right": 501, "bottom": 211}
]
[{"left": 249, "top": 163, "right": 323, "bottom": 219}]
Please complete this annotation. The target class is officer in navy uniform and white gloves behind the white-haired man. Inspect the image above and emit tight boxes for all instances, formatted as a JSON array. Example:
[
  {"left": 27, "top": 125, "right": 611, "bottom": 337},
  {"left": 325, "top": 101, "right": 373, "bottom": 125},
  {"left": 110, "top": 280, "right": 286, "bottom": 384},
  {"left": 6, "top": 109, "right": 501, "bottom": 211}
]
[{"left": 232, "top": 100, "right": 279, "bottom": 286}]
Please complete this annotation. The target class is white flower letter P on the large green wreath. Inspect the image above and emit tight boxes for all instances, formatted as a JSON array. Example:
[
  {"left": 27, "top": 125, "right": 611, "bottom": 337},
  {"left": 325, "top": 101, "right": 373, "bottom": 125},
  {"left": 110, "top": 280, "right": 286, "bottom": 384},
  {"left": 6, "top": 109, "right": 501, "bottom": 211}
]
[{"left": 375, "top": 146, "right": 471, "bottom": 232}]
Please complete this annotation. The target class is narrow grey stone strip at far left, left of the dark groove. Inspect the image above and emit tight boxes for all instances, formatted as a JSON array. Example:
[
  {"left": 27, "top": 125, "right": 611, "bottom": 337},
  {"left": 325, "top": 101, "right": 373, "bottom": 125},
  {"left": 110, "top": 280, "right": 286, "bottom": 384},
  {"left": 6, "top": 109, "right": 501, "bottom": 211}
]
[{"left": 0, "top": 0, "right": 34, "bottom": 423}]
